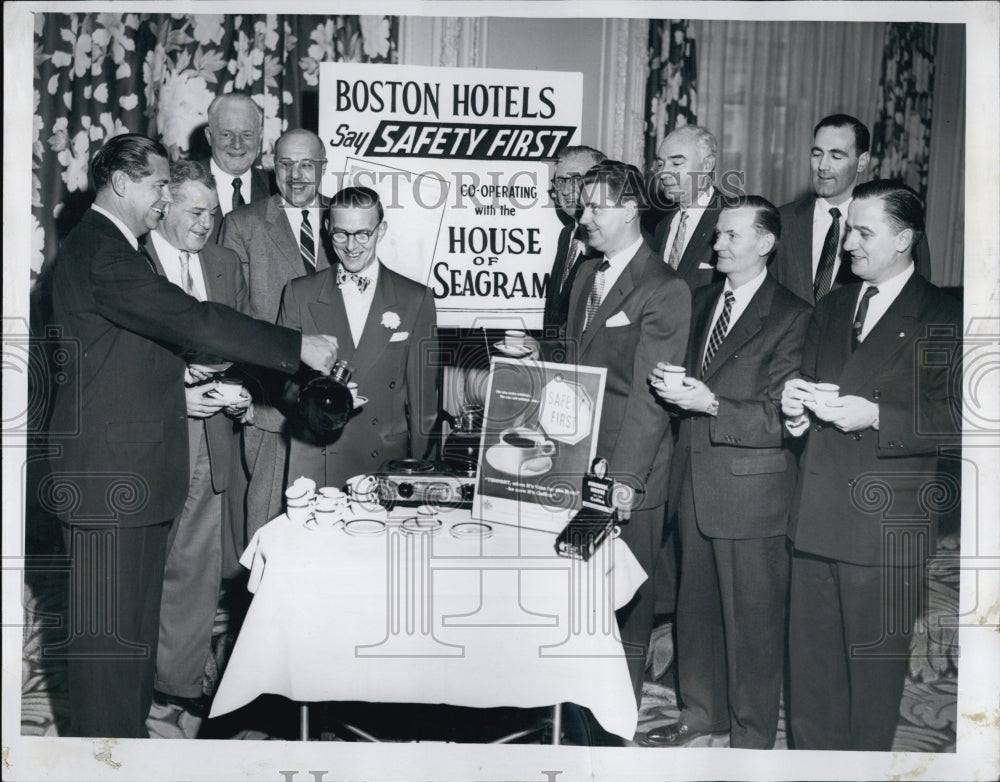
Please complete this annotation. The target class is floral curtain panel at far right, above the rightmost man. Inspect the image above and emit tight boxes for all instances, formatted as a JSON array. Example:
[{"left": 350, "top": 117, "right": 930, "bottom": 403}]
[{"left": 870, "top": 22, "right": 937, "bottom": 200}]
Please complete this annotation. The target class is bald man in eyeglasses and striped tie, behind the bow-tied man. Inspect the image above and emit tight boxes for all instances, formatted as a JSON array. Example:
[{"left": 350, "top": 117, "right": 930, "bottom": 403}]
[{"left": 222, "top": 130, "right": 330, "bottom": 550}]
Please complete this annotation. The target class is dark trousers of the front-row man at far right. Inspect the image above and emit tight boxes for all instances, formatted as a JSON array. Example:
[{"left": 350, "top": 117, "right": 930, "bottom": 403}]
[{"left": 788, "top": 552, "right": 923, "bottom": 752}]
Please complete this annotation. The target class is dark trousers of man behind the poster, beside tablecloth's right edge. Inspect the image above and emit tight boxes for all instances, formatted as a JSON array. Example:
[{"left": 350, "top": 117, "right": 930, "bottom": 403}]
[{"left": 615, "top": 505, "right": 663, "bottom": 704}]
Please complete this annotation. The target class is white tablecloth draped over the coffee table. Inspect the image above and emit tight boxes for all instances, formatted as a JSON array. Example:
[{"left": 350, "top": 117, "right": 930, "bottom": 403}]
[{"left": 211, "top": 511, "right": 646, "bottom": 738}]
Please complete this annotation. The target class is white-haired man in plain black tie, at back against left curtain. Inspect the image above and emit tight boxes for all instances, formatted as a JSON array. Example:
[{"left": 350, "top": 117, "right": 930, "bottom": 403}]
[{"left": 205, "top": 92, "right": 274, "bottom": 242}]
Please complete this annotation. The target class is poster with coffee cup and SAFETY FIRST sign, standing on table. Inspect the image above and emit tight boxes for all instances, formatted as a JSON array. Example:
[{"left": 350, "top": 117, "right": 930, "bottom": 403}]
[{"left": 472, "top": 357, "right": 606, "bottom": 533}]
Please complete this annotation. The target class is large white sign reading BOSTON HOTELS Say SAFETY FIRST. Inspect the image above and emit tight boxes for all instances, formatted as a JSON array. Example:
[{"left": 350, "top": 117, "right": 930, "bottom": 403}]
[{"left": 319, "top": 63, "right": 583, "bottom": 328}]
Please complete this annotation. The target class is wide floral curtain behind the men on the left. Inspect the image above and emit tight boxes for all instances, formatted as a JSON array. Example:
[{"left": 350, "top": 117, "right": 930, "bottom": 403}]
[{"left": 31, "top": 13, "right": 399, "bottom": 284}]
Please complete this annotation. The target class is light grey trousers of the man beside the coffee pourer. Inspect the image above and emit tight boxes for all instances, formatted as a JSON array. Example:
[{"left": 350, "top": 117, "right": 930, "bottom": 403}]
[{"left": 156, "top": 432, "right": 223, "bottom": 698}]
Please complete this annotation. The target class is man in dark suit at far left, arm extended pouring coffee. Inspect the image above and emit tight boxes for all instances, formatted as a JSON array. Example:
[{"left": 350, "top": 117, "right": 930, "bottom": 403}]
[{"left": 47, "top": 134, "right": 336, "bottom": 737}]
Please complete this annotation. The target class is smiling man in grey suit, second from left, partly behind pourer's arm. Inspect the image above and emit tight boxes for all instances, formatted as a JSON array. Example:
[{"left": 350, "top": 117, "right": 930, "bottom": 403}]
[{"left": 144, "top": 160, "right": 250, "bottom": 717}]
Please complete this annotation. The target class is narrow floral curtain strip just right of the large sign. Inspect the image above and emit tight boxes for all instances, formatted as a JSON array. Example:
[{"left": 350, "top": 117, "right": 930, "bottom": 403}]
[{"left": 645, "top": 19, "right": 698, "bottom": 173}]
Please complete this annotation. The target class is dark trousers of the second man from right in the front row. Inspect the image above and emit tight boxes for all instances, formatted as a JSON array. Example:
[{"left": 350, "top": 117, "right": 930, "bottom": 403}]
[{"left": 677, "top": 480, "right": 789, "bottom": 749}]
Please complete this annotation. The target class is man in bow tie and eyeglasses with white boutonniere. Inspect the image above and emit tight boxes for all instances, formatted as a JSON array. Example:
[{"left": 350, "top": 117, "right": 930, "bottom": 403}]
[{"left": 277, "top": 187, "right": 437, "bottom": 487}]
